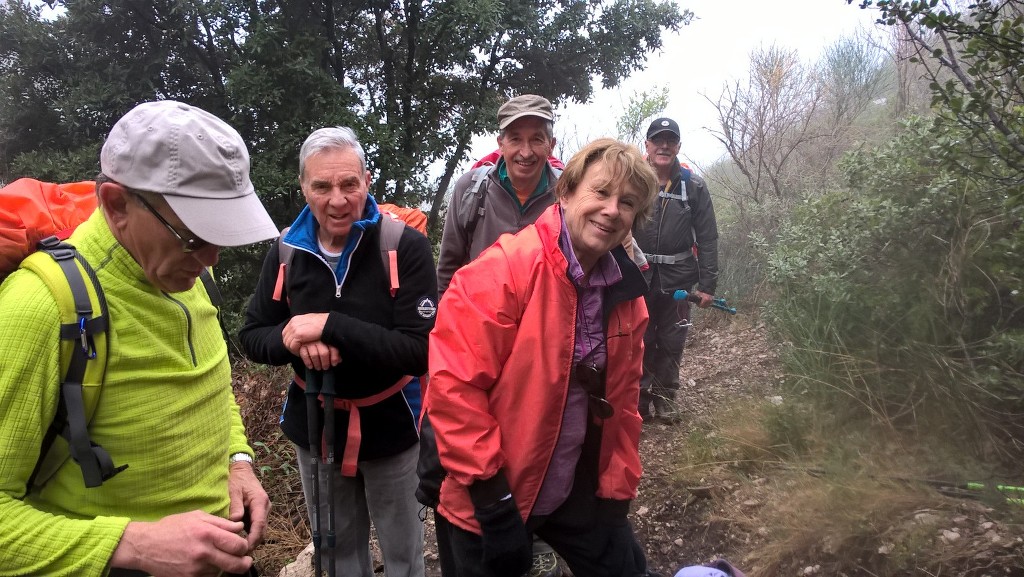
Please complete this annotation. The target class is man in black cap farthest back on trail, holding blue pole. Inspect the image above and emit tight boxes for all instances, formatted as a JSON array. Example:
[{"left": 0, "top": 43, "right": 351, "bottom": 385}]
[{"left": 633, "top": 118, "right": 718, "bottom": 423}]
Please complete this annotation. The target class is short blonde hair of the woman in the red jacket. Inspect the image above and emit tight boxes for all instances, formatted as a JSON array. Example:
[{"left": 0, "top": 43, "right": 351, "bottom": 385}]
[{"left": 555, "top": 138, "right": 657, "bottom": 221}]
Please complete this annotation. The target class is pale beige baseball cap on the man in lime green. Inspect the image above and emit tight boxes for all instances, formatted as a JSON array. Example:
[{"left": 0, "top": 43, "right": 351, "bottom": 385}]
[{"left": 99, "top": 100, "right": 279, "bottom": 246}]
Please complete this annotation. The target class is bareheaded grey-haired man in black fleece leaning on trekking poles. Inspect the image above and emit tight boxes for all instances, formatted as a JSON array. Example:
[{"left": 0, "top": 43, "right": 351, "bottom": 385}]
[{"left": 240, "top": 127, "right": 437, "bottom": 577}]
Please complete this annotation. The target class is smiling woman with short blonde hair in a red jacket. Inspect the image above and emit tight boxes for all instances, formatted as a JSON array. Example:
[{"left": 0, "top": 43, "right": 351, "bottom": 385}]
[{"left": 425, "top": 138, "right": 656, "bottom": 577}]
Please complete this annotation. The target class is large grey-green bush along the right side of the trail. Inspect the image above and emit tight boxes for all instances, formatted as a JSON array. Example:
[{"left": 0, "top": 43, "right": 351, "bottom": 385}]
[{"left": 768, "top": 119, "right": 1024, "bottom": 465}]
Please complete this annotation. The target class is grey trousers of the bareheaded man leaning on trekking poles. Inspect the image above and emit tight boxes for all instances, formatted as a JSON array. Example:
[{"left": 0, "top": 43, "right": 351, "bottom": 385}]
[{"left": 295, "top": 445, "right": 424, "bottom": 577}]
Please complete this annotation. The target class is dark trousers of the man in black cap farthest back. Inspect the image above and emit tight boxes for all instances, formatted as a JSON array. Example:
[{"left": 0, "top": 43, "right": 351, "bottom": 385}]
[{"left": 639, "top": 289, "right": 690, "bottom": 418}]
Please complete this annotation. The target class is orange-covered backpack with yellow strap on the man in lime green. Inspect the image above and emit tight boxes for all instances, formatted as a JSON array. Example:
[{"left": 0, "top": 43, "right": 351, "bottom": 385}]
[{"left": 0, "top": 178, "right": 221, "bottom": 491}]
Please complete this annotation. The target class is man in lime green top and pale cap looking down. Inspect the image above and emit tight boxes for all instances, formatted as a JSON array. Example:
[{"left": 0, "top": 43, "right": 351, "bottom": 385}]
[{"left": 0, "top": 101, "right": 278, "bottom": 576}]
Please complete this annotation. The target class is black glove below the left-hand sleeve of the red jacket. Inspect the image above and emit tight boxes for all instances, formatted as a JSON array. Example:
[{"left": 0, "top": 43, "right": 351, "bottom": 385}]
[{"left": 475, "top": 496, "right": 534, "bottom": 577}]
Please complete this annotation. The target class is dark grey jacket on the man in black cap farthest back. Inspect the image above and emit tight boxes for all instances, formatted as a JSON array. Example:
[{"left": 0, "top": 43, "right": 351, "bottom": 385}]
[{"left": 633, "top": 161, "right": 718, "bottom": 294}]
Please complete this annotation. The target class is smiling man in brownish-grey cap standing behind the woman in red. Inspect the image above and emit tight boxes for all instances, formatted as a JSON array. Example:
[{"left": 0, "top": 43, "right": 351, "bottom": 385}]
[{"left": 425, "top": 94, "right": 561, "bottom": 577}]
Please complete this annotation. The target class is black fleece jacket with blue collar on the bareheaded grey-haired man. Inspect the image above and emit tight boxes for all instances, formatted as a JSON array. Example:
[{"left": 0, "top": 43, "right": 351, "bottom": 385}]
[{"left": 239, "top": 199, "right": 437, "bottom": 460}]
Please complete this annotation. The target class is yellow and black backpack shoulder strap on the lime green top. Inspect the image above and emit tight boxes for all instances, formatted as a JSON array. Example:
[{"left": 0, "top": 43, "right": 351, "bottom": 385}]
[{"left": 22, "top": 238, "right": 127, "bottom": 490}]
